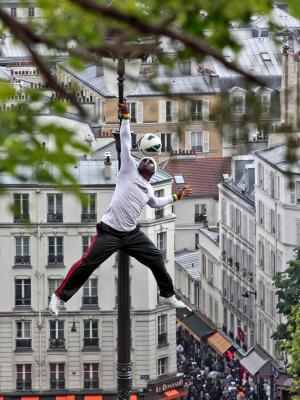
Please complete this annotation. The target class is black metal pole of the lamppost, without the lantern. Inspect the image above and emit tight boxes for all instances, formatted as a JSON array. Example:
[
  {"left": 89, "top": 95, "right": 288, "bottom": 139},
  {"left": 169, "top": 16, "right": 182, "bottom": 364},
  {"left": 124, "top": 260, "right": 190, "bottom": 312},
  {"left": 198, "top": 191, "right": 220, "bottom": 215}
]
[{"left": 115, "top": 58, "right": 132, "bottom": 400}]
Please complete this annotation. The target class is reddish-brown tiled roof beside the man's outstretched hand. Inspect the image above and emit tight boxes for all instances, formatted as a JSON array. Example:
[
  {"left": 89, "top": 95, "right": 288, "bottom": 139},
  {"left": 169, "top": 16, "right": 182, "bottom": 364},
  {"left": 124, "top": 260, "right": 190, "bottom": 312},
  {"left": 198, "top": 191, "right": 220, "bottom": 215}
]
[{"left": 161, "top": 157, "right": 231, "bottom": 197}]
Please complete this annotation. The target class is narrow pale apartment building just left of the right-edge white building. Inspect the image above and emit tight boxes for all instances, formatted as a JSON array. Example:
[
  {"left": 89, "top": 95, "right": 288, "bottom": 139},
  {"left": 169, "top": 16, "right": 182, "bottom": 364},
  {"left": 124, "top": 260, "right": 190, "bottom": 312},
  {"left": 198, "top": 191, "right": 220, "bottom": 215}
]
[{"left": 219, "top": 156, "right": 256, "bottom": 352}]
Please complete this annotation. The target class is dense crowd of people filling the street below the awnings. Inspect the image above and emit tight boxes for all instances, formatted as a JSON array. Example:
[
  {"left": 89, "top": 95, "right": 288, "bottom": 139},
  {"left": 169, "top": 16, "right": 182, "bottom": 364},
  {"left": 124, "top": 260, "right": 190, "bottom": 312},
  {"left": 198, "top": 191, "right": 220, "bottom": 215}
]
[{"left": 177, "top": 326, "right": 258, "bottom": 400}]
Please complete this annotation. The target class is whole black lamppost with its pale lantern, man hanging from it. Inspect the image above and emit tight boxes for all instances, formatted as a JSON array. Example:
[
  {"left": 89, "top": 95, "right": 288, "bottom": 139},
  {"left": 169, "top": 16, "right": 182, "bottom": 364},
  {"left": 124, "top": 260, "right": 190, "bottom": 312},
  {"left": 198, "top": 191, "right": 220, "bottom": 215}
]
[{"left": 102, "top": 47, "right": 143, "bottom": 400}]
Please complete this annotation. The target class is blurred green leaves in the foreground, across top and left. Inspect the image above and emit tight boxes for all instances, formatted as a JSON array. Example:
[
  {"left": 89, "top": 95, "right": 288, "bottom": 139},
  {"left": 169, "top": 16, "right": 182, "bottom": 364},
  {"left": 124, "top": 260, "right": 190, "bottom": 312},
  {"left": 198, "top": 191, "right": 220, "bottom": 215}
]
[{"left": 0, "top": 0, "right": 300, "bottom": 194}]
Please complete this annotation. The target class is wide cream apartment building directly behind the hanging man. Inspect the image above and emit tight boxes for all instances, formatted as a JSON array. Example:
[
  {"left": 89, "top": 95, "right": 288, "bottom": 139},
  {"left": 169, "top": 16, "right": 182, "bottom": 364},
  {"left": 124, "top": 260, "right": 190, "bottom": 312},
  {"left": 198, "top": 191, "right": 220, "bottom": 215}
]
[{"left": 0, "top": 155, "right": 178, "bottom": 398}]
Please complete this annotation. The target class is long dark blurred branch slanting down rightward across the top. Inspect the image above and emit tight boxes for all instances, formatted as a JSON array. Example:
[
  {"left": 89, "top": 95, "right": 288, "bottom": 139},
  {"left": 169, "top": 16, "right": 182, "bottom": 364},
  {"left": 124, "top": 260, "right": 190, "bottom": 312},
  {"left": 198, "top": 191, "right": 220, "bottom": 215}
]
[{"left": 71, "top": 0, "right": 265, "bottom": 86}]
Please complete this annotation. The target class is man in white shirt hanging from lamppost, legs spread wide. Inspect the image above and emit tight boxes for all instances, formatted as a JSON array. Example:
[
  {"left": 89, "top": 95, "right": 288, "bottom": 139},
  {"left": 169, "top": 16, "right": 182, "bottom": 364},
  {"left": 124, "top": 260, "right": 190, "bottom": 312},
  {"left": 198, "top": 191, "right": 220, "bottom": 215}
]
[{"left": 49, "top": 101, "right": 192, "bottom": 315}]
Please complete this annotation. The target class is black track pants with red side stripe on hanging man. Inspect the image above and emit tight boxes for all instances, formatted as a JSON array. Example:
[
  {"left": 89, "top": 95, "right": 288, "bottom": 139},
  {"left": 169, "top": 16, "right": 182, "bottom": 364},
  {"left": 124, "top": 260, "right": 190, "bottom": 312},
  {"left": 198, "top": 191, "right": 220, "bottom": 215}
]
[{"left": 55, "top": 222, "right": 174, "bottom": 302}]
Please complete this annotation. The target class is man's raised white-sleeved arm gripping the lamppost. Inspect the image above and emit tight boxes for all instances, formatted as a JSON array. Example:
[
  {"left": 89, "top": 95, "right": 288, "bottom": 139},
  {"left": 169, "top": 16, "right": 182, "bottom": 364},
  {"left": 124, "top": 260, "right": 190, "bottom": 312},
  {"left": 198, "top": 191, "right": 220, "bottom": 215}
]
[{"left": 119, "top": 101, "right": 135, "bottom": 170}]
